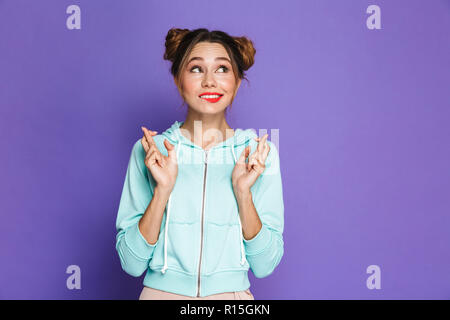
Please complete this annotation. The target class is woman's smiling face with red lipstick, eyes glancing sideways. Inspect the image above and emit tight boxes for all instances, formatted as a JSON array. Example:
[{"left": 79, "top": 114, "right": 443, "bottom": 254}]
[{"left": 177, "top": 42, "right": 241, "bottom": 114}]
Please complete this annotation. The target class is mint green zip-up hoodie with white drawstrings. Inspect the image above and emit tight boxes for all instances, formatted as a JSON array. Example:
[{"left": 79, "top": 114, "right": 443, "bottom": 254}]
[{"left": 116, "top": 121, "right": 284, "bottom": 297}]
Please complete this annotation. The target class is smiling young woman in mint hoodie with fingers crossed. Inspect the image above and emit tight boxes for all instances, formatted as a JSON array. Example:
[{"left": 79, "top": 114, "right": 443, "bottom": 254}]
[{"left": 116, "top": 28, "right": 284, "bottom": 299}]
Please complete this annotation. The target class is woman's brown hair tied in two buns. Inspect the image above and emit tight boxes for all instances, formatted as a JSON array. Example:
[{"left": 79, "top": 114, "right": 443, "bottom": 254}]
[{"left": 164, "top": 28, "right": 256, "bottom": 109}]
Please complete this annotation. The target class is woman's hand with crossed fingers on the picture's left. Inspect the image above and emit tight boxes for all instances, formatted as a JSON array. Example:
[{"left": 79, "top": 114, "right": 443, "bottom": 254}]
[{"left": 141, "top": 127, "right": 178, "bottom": 192}]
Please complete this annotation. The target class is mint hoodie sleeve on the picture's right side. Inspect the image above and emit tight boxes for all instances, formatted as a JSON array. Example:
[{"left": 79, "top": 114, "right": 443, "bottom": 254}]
[{"left": 244, "top": 141, "right": 284, "bottom": 278}]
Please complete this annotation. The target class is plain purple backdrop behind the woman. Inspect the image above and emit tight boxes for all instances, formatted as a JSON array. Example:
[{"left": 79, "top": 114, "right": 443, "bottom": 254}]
[{"left": 0, "top": 0, "right": 450, "bottom": 299}]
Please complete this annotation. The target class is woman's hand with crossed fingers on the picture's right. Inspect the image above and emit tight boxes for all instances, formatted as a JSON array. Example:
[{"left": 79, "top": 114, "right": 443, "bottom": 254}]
[{"left": 231, "top": 133, "right": 270, "bottom": 197}]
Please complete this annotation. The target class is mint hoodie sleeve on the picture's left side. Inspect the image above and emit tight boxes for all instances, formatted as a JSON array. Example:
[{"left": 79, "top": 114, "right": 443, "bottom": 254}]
[{"left": 116, "top": 140, "right": 158, "bottom": 277}]
